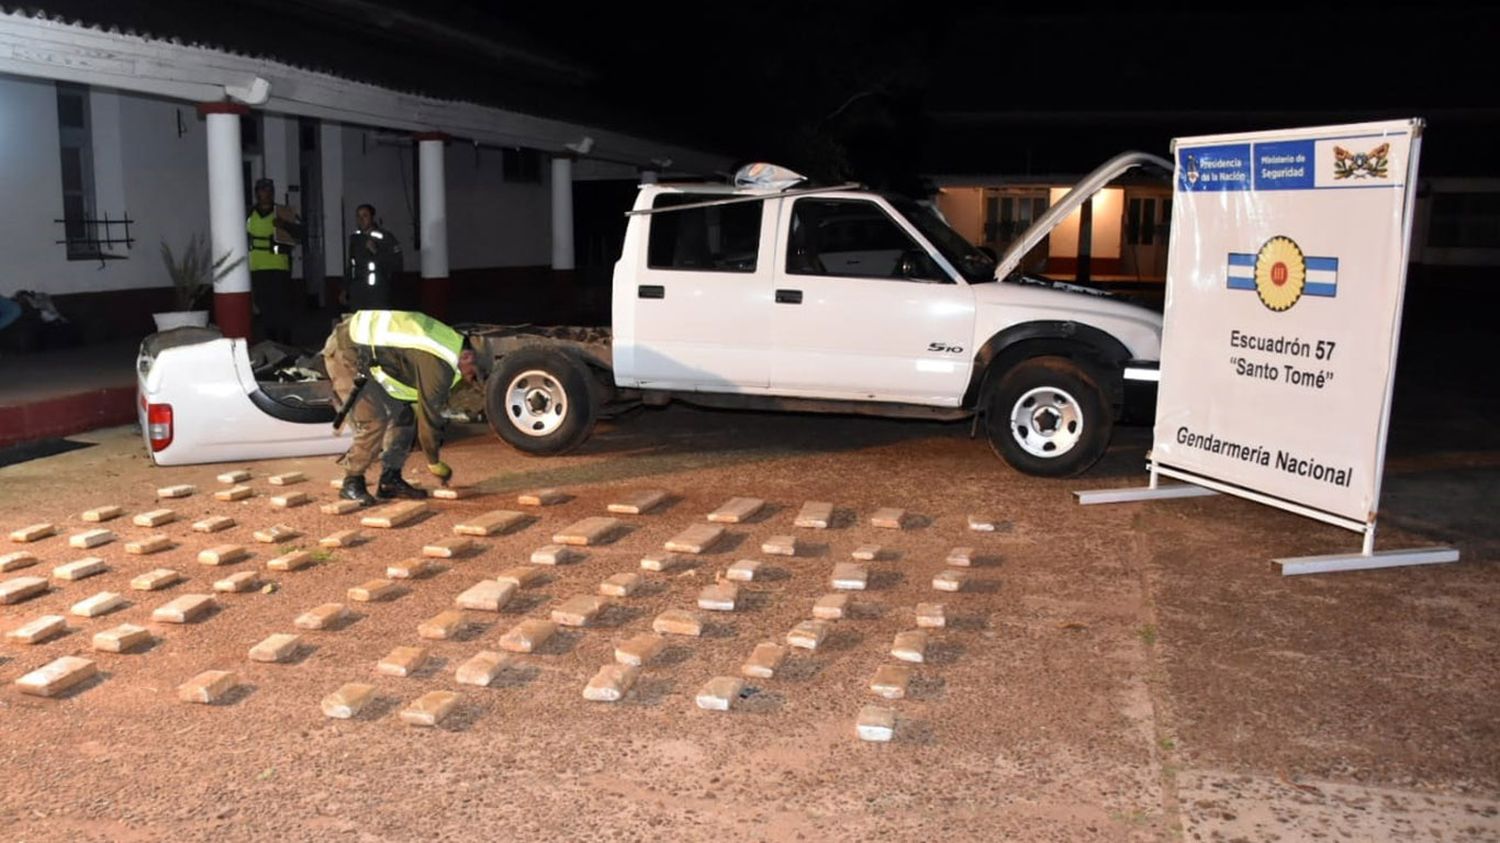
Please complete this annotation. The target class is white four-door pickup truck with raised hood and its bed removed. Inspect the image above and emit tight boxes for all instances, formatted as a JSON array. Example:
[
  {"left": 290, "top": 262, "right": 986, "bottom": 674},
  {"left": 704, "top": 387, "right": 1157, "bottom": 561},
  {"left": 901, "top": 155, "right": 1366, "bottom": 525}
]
[{"left": 486, "top": 153, "right": 1172, "bottom": 477}]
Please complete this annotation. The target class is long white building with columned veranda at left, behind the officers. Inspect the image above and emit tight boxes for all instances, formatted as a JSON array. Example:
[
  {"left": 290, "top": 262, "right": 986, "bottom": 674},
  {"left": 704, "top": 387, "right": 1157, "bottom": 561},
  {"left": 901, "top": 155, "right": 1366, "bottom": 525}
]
[{"left": 0, "top": 6, "right": 729, "bottom": 339}]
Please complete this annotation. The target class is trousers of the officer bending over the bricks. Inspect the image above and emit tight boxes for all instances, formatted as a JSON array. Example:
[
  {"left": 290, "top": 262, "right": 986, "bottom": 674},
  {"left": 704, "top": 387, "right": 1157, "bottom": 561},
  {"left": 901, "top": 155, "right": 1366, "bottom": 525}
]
[{"left": 323, "top": 321, "right": 417, "bottom": 477}]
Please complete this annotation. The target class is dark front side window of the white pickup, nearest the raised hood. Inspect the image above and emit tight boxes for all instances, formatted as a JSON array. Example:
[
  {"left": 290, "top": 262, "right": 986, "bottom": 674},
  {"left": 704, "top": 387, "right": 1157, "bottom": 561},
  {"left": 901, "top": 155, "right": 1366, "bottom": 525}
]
[{"left": 786, "top": 200, "right": 945, "bottom": 281}]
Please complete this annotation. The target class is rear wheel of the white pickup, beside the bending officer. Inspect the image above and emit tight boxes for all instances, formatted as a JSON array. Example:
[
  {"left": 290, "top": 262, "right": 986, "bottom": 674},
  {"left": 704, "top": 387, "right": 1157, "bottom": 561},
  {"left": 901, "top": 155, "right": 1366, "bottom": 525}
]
[{"left": 485, "top": 348, "right": 599, "bottom": 456}]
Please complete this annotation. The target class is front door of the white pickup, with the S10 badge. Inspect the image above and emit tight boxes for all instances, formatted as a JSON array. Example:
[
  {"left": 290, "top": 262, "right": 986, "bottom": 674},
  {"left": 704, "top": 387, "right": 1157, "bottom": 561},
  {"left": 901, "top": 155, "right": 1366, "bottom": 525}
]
[{"left": 771, "top": 197, "right": 974, "bottom": 407}]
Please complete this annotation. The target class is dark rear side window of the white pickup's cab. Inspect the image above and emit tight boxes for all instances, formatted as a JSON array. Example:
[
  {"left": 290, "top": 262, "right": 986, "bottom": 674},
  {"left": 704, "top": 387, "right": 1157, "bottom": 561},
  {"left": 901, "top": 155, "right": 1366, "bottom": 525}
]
[{"left": 647, "top": 194, "right": 764, "bottom": 272}]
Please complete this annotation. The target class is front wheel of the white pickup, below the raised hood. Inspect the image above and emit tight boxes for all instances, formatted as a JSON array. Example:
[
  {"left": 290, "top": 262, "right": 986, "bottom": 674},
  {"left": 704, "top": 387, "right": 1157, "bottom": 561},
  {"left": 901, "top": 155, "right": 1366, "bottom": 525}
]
[{"left": 984, "top": 357, "right": 1115, "bottom": 477}]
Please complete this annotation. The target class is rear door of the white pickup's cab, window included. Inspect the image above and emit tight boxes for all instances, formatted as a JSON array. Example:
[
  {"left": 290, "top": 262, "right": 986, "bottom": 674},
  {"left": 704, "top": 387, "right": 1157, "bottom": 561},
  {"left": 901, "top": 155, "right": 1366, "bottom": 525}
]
[{"left": 614, "top": 194, "right": 776, "bottom": 392}]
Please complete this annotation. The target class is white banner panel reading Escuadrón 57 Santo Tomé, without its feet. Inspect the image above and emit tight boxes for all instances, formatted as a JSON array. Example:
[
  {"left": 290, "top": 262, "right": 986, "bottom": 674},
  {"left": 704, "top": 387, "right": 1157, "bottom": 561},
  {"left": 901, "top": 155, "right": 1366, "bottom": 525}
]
[{"left": 1152, "top": 120, "right": 1422, "bottom": 528}]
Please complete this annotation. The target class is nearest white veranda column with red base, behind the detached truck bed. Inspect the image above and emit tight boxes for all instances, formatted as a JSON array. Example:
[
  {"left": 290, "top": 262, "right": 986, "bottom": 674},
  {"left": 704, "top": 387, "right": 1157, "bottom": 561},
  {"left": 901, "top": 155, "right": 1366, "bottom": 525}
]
[{"left": 198, "top": 102, "right": 251, "bottom": 339}]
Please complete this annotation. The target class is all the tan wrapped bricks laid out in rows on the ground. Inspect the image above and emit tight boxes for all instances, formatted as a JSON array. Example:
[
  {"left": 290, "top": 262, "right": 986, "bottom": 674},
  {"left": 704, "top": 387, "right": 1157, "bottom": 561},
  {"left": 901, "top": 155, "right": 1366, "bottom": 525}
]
[{"left": 0, "top": 471, "right": 995, "bottom": 741}]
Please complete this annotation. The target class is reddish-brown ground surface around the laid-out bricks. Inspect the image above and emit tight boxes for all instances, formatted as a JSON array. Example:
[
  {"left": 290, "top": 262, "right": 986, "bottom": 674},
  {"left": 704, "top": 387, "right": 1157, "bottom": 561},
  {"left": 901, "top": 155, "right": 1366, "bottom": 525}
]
[{"left": 0, "top": 408, "right": 1500, "bottom": 842}]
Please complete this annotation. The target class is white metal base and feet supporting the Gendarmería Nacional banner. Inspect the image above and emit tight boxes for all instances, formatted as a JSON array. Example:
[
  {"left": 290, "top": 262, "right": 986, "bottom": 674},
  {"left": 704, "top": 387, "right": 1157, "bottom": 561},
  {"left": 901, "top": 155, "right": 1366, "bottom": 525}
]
[{"left": 1073, "top": 462, "right": 1458, "bottom": 576}]
